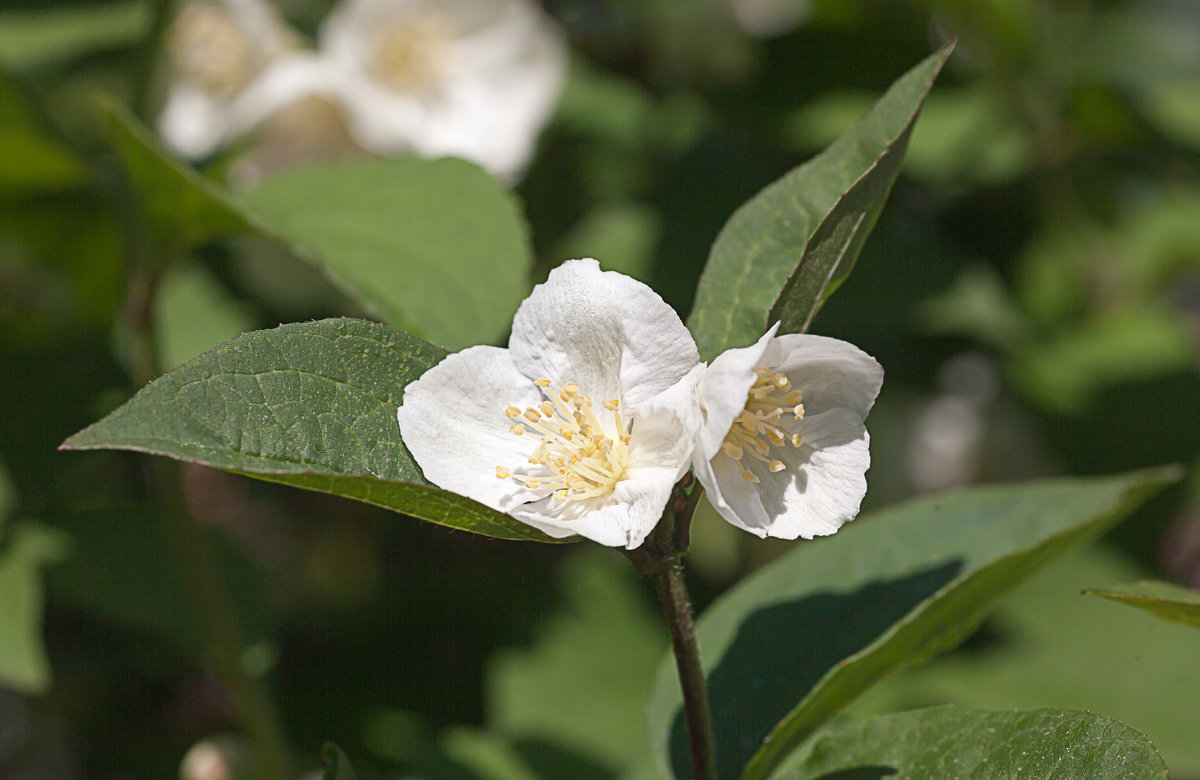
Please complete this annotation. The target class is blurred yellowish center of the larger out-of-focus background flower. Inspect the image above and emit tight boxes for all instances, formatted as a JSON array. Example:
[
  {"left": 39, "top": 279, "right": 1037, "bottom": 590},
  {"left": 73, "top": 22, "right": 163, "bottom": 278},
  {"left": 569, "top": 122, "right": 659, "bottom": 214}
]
[{"left": 373, "top": 12, "right": 454, "bottom": 94}]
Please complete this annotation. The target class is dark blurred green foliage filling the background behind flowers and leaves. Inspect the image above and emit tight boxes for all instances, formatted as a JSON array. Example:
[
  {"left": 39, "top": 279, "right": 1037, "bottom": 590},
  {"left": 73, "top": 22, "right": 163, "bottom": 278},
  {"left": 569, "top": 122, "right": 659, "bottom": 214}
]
[{"left": 0, "top": 0, "right": 1200, "bottom": 779}]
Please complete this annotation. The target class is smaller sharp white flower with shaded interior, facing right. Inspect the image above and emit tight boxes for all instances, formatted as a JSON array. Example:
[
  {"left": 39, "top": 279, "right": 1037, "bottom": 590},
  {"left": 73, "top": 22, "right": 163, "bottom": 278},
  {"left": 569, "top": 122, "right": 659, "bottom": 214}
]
[{"left": 694, "top": 324, "right": 883, "bottom": 539}]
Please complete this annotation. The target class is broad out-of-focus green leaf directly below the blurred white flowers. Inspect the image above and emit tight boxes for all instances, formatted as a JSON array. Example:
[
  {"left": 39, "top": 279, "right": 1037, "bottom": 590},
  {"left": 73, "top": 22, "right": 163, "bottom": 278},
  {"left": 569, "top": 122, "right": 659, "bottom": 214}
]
[{"left": 239, "top": 158, "right": 533, "bottom": 349}]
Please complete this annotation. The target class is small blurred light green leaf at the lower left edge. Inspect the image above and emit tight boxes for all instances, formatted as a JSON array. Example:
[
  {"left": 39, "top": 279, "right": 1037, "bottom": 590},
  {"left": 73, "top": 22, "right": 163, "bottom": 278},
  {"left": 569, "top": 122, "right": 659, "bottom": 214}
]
[{"left": 0, "top": 523, "right": 65, "bottom": 695}]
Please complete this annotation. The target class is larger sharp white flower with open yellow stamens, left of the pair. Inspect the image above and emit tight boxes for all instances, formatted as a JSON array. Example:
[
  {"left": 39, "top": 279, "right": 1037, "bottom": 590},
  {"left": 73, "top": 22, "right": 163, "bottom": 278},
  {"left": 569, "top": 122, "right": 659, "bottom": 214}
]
[{"left": 397, "top": 259, "right": 701, "bottom": 548}]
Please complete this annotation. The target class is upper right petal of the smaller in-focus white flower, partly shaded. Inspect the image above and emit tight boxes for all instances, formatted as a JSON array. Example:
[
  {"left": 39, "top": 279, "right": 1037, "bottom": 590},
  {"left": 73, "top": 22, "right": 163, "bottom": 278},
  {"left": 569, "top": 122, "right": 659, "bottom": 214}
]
[{"left": 763, "top": 334, "right": 883, "bottom": 419}]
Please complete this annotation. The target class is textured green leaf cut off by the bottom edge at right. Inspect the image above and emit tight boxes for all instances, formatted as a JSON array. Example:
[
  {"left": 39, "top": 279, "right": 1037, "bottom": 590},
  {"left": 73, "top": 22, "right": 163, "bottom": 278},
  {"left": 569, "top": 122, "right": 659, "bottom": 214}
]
[{"left": 772, "top": 706, "right": 1168, "bottom": 780}]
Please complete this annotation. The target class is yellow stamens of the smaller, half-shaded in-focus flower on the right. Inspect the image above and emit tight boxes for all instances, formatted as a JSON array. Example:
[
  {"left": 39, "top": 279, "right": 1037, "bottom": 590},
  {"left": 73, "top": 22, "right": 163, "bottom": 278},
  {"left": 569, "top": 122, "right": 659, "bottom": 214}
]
[{"left": 721, "top": 366, "right": 804, "bottom": 482}]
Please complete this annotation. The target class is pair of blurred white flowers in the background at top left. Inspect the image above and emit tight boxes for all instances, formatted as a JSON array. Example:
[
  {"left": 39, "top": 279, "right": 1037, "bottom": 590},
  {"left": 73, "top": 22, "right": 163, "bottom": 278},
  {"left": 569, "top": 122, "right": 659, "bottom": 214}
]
[{"left": 158, "top": 0, "right": 566, "bottom": 180}]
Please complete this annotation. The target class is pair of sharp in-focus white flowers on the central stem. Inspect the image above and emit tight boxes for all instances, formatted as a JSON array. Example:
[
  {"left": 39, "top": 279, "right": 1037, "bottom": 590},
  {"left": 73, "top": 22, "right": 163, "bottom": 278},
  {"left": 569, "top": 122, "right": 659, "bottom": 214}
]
[{"left": 397, "top": 259, "right": 883, "bottom": 548}]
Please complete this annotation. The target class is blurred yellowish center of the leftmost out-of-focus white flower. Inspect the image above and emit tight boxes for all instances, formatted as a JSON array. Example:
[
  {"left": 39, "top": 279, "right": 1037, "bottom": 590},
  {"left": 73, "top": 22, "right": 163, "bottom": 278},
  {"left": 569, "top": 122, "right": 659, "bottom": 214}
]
[{"left": 169, "top": 2, "right": 254, "bottom": 97}]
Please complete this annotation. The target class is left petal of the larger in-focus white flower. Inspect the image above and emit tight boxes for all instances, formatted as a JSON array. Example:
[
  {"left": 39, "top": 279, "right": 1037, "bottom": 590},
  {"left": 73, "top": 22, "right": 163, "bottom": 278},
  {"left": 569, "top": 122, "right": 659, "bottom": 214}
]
[{"left": 396, "top": 347, "right": 542, "bottom": 511}]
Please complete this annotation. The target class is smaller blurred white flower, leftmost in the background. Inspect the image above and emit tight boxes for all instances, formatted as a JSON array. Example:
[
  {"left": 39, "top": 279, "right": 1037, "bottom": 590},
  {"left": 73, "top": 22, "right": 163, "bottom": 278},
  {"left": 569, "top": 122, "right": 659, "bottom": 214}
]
[{"left": 158, "top": 0, "right": 295, "bottom": 160}]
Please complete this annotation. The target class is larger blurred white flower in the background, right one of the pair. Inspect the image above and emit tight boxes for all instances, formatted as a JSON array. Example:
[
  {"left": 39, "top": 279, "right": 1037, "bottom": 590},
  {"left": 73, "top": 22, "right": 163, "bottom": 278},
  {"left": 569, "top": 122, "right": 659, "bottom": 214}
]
[{"left": 319, "top": 0, "right": 566, "bottom": 180}]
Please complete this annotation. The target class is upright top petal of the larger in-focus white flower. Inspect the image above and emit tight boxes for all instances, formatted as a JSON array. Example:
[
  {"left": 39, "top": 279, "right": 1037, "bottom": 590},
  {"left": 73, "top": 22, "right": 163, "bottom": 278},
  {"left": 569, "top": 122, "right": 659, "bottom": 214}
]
[{"left": 509, "top": 259, "right": 700, "bottom": 419}]
